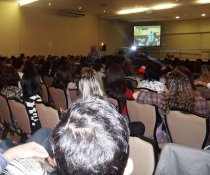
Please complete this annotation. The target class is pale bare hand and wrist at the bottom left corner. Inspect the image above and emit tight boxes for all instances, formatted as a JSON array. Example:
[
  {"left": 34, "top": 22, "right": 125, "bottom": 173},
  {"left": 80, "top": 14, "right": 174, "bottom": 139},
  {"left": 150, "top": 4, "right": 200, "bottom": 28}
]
[{"left": 3, "top": 142, "right": 49, "bottom": 161}]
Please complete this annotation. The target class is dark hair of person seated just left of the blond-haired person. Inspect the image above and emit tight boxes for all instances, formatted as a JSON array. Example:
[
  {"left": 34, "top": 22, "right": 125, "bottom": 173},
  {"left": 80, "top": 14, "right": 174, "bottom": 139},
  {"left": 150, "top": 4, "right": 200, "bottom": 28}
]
[{"left": 52, "top": 66, "right": 72, "bottom": 89}]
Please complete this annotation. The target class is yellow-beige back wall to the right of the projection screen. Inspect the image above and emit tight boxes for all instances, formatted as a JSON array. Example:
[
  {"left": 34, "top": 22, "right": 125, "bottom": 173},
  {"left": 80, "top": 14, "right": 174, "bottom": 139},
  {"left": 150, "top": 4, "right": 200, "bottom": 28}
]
[{"left": 140, "top": 18, "right": 210, "bottom": 59}]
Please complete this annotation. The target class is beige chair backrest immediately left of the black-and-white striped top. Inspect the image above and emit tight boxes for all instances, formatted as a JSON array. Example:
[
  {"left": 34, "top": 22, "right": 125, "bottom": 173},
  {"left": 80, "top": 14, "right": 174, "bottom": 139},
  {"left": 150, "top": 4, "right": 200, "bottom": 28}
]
[{"left": 7, "top": 99, "right": 31, "bottom": 134}]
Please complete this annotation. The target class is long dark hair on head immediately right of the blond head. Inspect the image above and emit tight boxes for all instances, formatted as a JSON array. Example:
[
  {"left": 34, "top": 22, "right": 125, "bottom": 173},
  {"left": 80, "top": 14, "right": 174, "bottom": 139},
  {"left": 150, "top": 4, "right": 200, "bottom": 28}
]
[{"left": 104, "top": 63, "right": 126, "bottom": 99}]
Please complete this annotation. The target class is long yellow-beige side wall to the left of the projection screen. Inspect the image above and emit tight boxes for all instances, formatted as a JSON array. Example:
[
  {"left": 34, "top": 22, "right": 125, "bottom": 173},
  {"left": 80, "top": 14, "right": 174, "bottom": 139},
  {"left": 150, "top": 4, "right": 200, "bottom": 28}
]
[{"left": 0, "top": 2, "right": 132, "bottom": 56}]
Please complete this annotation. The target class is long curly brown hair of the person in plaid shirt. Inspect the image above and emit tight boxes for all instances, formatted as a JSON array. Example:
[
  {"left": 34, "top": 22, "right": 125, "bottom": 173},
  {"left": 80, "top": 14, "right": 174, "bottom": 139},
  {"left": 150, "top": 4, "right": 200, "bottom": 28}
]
[{"left": 166, "top": 71, "right": 194, "bottom": 111}]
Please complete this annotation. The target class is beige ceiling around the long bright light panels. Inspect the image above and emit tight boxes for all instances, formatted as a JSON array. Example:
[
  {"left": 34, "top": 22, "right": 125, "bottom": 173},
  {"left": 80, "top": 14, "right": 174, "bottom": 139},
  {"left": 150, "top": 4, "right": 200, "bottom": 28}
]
[{"left": 0, "top": 0, "right": 210, "bottom": 22}]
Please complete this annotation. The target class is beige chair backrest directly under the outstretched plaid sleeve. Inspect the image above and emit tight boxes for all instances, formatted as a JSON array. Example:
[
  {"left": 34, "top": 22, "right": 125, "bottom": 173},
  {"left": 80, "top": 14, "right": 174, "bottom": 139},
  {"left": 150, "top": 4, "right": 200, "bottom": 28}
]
[{"left": 127, "top": 100, "right": 156, "bottom": 138}]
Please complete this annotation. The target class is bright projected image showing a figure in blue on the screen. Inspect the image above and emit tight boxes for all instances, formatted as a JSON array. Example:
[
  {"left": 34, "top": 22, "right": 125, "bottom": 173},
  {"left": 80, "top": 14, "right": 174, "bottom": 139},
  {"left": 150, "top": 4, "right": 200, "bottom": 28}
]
[{"left": 134, "top": 25, "right": 161, "bottom": 47}]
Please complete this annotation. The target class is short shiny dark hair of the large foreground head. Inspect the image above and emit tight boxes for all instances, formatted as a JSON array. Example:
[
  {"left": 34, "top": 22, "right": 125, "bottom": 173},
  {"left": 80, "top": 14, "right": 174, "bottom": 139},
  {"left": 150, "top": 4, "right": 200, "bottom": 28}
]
[{"left": 52, "top": 96, "right": 129, "bottom": 175}]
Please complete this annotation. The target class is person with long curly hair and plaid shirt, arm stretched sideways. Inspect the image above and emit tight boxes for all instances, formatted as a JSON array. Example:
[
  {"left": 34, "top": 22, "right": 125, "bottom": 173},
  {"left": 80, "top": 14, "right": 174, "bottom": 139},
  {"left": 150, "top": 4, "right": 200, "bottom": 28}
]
[{"left": 133, "top": 71, "right": 210, "bottom": 120}]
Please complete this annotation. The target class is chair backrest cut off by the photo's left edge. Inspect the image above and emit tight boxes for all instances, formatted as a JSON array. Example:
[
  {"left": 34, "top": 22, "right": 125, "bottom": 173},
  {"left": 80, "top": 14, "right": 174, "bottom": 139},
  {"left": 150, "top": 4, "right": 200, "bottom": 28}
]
[{"left": 0, "top": 95, "right": 12, "bottom": 124}]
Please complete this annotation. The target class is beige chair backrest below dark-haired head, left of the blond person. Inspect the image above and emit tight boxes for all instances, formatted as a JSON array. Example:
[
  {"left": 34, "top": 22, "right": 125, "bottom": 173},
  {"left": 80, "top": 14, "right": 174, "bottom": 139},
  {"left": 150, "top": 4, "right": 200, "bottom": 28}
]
[{"left": 49, "top": 87, "right": 68, "bottom": 110}]
